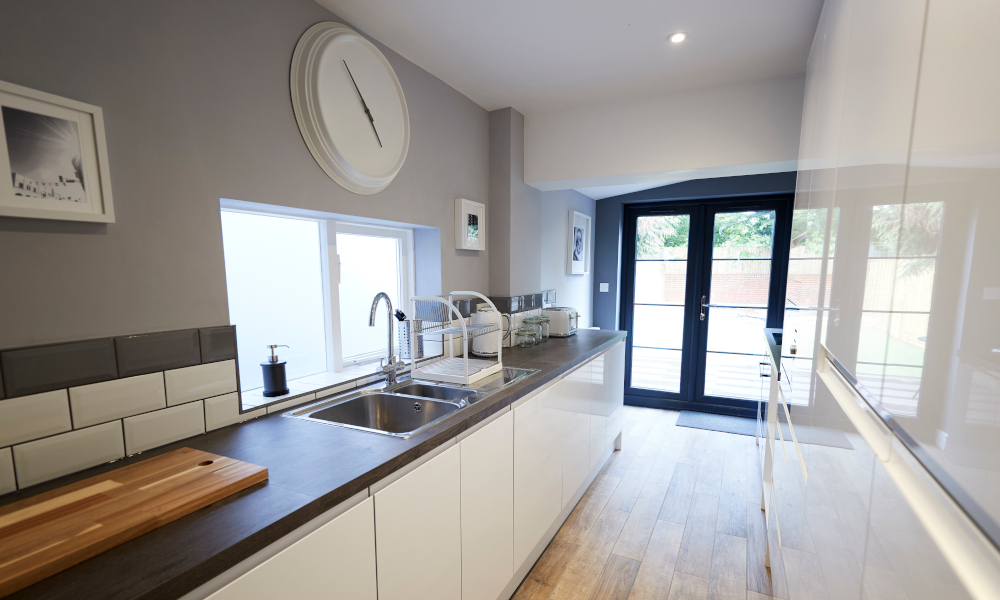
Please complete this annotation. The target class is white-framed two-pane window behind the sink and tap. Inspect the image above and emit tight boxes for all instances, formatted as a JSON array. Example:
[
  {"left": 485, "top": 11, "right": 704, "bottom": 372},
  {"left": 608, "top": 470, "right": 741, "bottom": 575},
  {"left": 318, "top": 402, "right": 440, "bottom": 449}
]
[{"left": 222, "top": 208, "right": 414, "bottom": 390}]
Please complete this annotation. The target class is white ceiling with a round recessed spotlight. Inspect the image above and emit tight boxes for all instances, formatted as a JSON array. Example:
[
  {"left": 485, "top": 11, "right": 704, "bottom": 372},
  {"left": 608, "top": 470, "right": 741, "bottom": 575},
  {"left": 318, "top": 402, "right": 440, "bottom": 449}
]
[{"left": 317, "top": 0, "right": 822, "bottom": 114}]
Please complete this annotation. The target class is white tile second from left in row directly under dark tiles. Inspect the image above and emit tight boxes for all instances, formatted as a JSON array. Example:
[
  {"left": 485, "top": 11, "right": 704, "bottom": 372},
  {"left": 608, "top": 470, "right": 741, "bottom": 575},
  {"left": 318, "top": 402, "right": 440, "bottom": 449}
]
[{"left": 69, "top": 373, "right": 167, "bottom": 429}]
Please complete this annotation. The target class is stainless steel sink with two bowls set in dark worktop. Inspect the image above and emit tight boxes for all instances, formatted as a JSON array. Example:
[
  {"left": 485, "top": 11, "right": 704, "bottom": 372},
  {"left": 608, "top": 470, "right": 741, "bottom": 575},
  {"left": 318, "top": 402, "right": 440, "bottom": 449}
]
[{"left": 287, "top": 392, "right": 467, "bottom": 439}]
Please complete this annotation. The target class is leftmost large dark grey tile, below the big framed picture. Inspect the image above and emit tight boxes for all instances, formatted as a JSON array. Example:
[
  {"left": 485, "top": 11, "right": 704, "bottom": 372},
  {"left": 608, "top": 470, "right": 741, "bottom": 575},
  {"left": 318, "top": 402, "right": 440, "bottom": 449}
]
[{"left": 0, "top": 338, "right": 118, "bottom": 398}]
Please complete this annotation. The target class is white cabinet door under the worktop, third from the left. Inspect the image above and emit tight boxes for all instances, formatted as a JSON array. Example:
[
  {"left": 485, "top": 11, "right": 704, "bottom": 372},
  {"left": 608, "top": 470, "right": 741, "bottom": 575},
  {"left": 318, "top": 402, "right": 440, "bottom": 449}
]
[{"left": 461, "top": 412, "right": 514, "bottom": 600}]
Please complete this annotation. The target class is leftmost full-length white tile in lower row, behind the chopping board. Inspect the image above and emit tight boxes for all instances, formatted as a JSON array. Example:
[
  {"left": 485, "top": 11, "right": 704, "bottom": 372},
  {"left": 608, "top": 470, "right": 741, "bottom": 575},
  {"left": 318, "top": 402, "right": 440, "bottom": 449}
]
[{"left": 14, "top": 421, "right": 125, "bottom": 489}]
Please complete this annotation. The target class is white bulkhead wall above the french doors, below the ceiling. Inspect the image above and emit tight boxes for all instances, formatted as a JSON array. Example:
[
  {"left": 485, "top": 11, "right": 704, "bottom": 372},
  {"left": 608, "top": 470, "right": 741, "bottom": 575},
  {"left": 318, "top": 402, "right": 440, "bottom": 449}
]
[{"left": 524, "top": 77, "right": 805, "bottom": 190}]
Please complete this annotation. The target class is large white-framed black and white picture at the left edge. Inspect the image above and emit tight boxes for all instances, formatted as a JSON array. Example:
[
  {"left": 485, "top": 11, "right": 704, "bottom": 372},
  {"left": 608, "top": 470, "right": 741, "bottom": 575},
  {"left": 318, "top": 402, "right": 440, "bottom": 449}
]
[{"left": 0, "top": 81, "right": 115, "bottom": 223}]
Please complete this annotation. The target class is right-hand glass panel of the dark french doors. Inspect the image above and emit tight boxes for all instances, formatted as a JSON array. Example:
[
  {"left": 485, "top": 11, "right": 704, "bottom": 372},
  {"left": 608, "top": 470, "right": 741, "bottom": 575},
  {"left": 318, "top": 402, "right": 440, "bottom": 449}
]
[{"left": 701, "top": 210, "right": 777, "bottom": 400}]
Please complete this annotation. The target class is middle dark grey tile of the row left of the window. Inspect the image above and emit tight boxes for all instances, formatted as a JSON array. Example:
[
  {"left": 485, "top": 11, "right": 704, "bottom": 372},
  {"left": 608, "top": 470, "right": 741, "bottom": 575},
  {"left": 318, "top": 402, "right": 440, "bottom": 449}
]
[{"left": 115, "top": 329, "right": 201, "bottom": 377}]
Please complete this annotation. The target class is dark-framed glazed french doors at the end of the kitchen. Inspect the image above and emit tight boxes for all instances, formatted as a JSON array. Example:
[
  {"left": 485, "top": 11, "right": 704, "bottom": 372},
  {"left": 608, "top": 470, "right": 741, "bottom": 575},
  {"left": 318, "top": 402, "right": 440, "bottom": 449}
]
[{"left": 620, "top": 195, "right": 792, "bottom": 416}]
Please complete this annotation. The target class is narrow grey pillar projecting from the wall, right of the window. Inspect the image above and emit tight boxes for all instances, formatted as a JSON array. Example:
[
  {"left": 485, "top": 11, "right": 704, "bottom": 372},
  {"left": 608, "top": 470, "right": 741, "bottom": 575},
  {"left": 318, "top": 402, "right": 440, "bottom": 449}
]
[{"left": 487, "top": 108, "right": 543, "bottom": 296}]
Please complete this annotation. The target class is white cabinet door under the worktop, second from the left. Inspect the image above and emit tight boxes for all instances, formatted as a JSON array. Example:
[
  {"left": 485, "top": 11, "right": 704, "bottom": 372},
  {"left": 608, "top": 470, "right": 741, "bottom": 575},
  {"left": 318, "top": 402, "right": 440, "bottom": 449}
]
[{"left": 376, "top": 445, "right": 462, "bottom": 600}]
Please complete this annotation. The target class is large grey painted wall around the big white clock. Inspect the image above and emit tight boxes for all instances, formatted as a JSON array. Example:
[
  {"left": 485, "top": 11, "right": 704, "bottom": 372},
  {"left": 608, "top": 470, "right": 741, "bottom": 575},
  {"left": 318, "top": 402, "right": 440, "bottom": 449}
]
[{"left": 0, "top": 0, "right": 489, "bottom": 348}]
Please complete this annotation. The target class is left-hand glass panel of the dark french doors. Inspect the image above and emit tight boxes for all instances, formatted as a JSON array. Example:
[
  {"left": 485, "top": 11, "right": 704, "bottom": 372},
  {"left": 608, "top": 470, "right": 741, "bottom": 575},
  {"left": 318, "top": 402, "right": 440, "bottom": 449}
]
[{"left": 631, "top": 214, "right": 691, "bottom": 393}]
